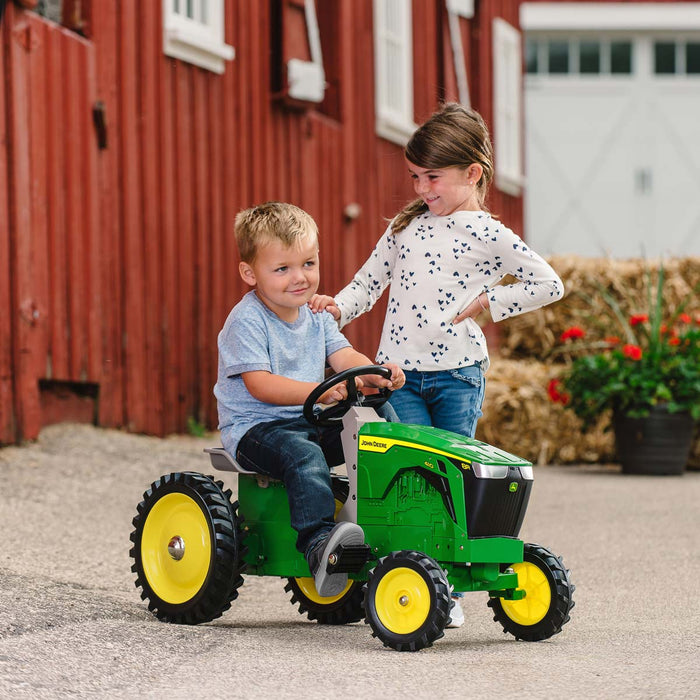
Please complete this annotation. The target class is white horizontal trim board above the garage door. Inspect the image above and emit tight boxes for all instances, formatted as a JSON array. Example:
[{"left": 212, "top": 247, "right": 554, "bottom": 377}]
[{"left": 520, "top": 2, "right": 700, "bottom": 31}]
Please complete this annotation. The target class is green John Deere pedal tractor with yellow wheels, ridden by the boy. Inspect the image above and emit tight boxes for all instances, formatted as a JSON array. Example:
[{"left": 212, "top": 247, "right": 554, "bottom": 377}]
[{"left": 130, "top": 366, "right": 574, "bottom": 651}]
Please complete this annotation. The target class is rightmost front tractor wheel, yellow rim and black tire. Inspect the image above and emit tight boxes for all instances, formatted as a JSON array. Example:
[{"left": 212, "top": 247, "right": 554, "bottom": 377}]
[{"left": 488, "top": 543, "right": 576, "bottom": 642}]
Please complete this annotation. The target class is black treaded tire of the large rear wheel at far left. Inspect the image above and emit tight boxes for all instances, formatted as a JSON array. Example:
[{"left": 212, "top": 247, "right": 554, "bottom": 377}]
[{"left": 129, "top": 472, "right": 247, "bottom": 625}]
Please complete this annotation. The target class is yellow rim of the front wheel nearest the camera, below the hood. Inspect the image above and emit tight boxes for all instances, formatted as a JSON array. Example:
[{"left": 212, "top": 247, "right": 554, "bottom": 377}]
[{"left": 374, "top": 566, "right": 430, "bottom": 634}]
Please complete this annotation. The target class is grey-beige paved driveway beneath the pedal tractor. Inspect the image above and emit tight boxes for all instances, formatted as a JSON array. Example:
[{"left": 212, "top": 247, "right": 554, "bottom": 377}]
[{"left": 0, "top": 426, "right": 700, "bottom": 700}]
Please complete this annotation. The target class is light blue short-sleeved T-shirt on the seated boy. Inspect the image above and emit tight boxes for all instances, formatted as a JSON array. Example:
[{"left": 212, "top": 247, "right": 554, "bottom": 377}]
[{"left": 214, "top": 292, "right": 350, "bottom": 455}]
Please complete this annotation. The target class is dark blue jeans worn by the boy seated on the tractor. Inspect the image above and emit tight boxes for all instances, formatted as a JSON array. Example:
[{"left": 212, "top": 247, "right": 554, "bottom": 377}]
[{"left": 236, "top": 403, "right": 398, "bottom": 554}]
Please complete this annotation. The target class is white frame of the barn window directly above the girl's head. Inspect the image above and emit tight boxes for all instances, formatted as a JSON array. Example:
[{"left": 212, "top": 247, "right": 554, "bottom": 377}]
[{"left": 374, "top": 0, "right": 417, "bottom": 146}]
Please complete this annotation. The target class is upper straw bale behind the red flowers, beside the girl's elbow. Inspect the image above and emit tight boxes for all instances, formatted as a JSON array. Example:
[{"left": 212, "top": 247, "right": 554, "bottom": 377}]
[{"left": 499, "top": 255, "right": 700, "bottom": 359}]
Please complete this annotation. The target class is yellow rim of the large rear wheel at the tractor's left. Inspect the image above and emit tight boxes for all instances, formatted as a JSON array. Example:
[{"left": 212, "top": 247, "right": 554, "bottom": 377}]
[{"left": 141, "top": 493, "right": 211, "bottom": 605}]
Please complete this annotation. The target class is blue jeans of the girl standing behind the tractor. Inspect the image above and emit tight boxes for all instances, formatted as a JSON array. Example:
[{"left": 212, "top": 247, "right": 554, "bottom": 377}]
[{"left": 391, "top": 364, "right": 486, "bottom": 437}]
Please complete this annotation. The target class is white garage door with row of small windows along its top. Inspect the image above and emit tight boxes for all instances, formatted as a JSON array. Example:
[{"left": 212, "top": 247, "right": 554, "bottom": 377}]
[{"left": 525, "top": 7, "right": 700, "bottom": 257}]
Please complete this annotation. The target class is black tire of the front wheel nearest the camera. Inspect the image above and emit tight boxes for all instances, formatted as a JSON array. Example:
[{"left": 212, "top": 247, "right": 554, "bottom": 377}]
[{"left": 364, "top": 550, "right": 452, "bottom": 651}]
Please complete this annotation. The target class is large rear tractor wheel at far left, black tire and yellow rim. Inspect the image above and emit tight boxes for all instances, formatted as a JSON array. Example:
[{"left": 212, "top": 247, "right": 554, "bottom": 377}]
[{"left": 129, "top": 472, "right": 245, "bottom": 625}]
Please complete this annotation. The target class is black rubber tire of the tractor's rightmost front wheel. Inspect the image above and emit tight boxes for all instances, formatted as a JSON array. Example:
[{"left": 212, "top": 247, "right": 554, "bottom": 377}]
[{"left": 488, "top": 543, "right": 576, "bottom": 642}]
